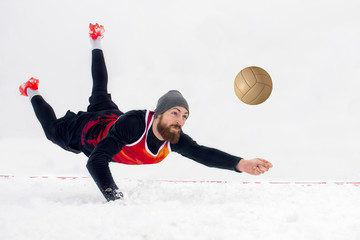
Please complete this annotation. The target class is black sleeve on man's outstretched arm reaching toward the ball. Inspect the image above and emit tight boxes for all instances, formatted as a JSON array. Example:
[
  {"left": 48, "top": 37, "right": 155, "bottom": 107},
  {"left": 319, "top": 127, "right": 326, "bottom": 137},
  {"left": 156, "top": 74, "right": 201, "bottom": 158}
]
[{"left": 171, "top": 133, "right": 242, "bottom": 172}]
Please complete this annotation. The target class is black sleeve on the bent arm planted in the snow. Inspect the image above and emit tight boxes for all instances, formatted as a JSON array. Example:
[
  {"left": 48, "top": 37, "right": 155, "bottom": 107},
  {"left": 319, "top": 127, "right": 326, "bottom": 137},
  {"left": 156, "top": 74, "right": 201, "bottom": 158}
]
[{"left": 86, "top": 111, "right": 145, "bottom": 201}]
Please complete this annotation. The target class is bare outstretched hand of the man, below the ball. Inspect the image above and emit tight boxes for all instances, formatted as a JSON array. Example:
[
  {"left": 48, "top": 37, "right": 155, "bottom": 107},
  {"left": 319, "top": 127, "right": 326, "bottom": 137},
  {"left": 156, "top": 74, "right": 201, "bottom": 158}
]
[{"left": 236, "top": 158, "right": 272, "bottom": 175}]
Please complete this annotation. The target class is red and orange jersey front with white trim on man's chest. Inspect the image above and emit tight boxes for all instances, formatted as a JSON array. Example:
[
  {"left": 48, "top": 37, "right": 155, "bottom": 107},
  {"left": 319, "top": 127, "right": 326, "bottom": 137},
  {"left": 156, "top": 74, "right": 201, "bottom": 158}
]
[{"left": 113, "top": 111, "right": 171, "bottom": 165}]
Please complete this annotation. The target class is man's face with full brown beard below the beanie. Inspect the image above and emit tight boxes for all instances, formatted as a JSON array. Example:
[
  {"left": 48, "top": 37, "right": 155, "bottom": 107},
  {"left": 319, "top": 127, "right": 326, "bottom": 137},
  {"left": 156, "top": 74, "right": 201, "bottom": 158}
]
[{"left": 157, "top": 106, "right": 189, "bottom": 144}]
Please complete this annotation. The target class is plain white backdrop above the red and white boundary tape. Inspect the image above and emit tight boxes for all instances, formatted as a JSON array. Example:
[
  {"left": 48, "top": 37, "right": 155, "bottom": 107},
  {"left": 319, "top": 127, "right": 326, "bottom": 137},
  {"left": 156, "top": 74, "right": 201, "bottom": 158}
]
[{"left": 0, "top": 0, "right": 360, "bottom": 181}]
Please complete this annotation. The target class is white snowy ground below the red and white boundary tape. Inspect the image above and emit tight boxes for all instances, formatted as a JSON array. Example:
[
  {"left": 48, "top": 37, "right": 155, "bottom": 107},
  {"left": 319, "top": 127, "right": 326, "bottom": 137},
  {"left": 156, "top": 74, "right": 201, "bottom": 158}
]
[{"left": 0, "top": 177, "right": 360, "bottom": 240}]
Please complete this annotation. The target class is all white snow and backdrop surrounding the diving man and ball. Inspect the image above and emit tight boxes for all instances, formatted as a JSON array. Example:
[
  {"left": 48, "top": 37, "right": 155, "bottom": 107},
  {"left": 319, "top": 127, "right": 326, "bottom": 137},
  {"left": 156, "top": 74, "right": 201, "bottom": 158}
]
[{"left": 0, "top": 0, "right": 360, "bottom": 240}]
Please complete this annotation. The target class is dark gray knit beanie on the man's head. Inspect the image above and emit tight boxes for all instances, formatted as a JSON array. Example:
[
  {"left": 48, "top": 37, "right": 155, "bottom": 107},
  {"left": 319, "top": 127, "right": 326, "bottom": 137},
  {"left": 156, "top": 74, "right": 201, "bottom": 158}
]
[{"left": 154, "top": 90, "right": 189, "bottom": 118}]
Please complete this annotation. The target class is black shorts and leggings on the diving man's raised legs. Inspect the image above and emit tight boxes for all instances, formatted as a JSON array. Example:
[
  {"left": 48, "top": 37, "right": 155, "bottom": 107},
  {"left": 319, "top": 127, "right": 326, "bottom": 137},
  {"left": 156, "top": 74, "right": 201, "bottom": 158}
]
[{"left": 31, "top": 49, "right": 122, "bottom": 153}]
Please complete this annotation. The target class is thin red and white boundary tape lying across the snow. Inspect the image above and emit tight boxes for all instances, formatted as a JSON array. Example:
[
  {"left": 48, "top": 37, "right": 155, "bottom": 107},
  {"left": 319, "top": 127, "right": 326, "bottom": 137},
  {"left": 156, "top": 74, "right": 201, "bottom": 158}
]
[{"left": 0, "top": 175, "right": 360, "bottom": 186}]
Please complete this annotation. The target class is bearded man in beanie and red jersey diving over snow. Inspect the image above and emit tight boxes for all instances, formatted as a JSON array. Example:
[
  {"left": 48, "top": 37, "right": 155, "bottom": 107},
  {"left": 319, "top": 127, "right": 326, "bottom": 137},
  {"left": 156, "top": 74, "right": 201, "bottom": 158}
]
[{"left": 20, "top": 24, "right": 272, "bottom": 201}]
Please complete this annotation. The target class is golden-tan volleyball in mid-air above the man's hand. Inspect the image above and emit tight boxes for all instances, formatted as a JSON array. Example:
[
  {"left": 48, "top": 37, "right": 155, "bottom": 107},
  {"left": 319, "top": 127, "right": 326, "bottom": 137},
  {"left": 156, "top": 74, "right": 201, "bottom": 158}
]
[{"left": 234, "top": 67, "right": 272, "bottom": 105}]
